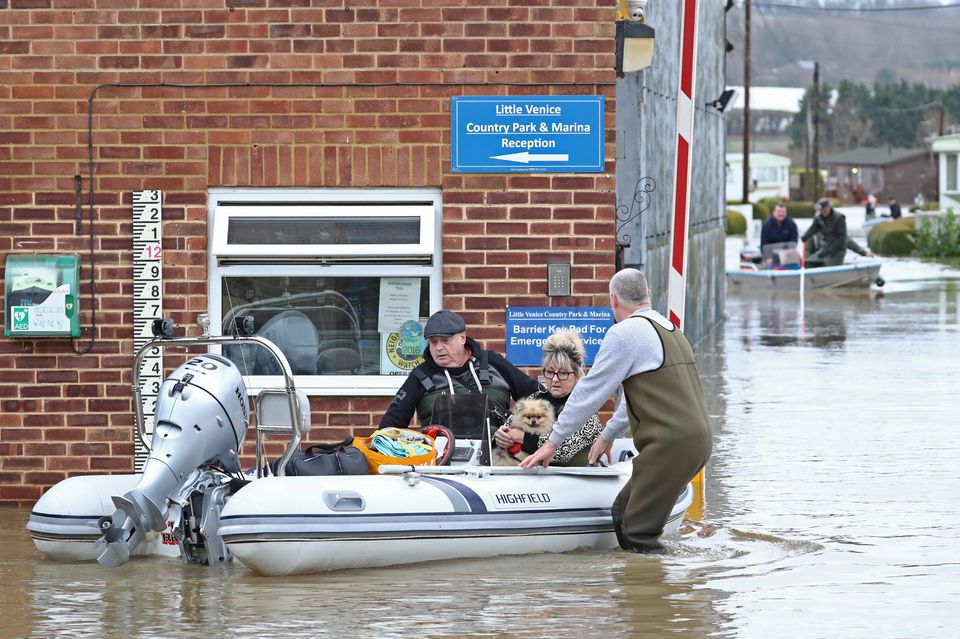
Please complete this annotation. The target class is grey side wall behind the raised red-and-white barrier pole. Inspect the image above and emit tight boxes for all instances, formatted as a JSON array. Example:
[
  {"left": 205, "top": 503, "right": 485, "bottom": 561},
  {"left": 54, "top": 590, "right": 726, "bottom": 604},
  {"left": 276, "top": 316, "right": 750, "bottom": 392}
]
[{"left": 617, "top": 2, "right": 725, "bottom": 342}]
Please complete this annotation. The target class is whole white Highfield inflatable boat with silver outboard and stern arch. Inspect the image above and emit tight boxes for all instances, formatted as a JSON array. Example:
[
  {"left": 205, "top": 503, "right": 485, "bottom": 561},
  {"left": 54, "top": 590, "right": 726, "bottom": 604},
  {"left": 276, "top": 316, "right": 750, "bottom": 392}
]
[{"left": 27, "top": 322, "right": 693, "bottom": 575}]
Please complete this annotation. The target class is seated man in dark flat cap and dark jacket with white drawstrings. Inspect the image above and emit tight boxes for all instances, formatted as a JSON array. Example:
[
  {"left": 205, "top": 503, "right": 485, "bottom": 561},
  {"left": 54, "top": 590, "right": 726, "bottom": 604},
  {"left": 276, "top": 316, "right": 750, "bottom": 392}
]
[{"left": 379, "top": 310, "right": 540, "bottom": 428}]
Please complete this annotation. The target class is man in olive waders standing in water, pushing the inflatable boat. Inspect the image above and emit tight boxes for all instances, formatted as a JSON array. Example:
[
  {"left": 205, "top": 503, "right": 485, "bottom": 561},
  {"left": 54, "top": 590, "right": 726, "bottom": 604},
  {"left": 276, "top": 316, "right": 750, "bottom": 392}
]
[{"left": 521, "top": 269, "right": 713, "bottom": 552}]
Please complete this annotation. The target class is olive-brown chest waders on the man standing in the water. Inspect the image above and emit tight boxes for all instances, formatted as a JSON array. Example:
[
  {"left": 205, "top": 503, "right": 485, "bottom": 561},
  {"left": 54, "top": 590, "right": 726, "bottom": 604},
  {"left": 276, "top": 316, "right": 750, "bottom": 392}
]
[{"left": 611, "top": 317, "right": 713, "bottom": 552}]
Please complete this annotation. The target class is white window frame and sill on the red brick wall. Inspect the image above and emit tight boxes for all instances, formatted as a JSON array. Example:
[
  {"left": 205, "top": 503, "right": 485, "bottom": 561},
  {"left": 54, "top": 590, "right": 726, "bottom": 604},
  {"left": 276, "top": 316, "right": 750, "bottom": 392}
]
[{"left": 207, "top": 188, "right": 443, "bottom": 396}]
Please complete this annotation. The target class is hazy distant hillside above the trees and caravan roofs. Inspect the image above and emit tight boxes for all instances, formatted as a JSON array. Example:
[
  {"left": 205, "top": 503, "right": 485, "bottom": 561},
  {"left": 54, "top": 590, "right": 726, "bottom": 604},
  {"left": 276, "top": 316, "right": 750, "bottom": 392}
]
[{"left": 727, "top": 0, "right": 960, "bottom": 88}]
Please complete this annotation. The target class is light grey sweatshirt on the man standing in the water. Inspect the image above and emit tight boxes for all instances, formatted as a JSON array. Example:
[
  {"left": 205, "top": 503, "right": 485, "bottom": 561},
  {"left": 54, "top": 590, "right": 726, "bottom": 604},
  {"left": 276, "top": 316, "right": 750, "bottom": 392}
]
[{"left": 550, "top": 309, "right": 673, "bottom": 446}]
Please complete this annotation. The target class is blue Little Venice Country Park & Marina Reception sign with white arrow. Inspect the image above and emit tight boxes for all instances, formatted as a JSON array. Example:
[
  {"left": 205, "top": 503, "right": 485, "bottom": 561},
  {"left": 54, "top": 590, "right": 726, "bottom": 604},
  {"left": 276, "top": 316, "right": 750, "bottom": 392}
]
[{"left": 450, "top": 95, "right": 604, "bottom": 173}]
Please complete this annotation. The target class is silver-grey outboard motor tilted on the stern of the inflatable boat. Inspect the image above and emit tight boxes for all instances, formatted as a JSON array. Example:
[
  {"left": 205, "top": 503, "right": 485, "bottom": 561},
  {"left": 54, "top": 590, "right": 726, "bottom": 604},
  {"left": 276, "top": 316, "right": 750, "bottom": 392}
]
[{"left": 97, "top": 353, "right": 250, "bottom": 566}]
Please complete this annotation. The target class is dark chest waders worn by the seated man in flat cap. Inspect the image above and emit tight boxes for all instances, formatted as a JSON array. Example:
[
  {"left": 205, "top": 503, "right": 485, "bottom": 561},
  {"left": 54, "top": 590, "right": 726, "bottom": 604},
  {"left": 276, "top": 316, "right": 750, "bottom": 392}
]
[{"left": 412, "top": 351, "right": 510, "bottom": 428}]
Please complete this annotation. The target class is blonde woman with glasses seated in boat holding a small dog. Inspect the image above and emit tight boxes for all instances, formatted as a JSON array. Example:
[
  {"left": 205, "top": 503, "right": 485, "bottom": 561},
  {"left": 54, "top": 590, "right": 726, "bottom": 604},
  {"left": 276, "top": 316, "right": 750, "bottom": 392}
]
[{"left": 494, "top": 330, "right": 603, "bottom": 466}]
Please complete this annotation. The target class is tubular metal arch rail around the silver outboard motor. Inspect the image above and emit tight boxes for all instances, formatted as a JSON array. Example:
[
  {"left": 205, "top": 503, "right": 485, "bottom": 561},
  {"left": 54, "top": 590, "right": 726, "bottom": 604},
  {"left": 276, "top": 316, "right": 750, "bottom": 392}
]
[{"left": 131, "top": 318, "right": 309, "bottom": 477}]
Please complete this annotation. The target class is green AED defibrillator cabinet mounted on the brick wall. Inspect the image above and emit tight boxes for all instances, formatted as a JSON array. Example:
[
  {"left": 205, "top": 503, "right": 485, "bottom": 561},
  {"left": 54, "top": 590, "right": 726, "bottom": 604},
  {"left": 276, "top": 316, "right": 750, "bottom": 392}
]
[{"left": 3, "top": 255, "right": 80, "bottom": 337}]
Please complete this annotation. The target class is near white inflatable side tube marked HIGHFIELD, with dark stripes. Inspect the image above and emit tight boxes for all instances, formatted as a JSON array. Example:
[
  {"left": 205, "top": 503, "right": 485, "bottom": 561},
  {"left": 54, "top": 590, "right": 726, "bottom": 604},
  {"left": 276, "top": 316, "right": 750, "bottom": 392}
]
[{"left": 219, "top": 461, "right": 693, "bottom": 575}]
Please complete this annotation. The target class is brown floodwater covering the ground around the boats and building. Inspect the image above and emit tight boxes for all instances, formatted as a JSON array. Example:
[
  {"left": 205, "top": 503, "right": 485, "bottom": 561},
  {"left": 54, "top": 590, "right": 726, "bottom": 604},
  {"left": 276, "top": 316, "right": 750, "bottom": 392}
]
[{"left": 0, "top": 248, "right": 960, "bottom": 639}]
